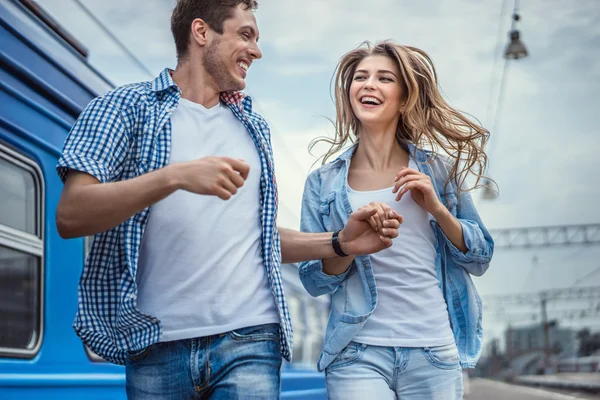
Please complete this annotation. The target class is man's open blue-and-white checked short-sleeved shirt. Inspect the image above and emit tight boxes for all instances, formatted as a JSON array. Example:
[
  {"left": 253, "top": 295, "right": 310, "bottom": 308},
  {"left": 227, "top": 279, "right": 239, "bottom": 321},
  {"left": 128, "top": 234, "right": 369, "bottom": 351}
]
[{"left": 56, "top": 69, "right": 293, "bottom": 364}]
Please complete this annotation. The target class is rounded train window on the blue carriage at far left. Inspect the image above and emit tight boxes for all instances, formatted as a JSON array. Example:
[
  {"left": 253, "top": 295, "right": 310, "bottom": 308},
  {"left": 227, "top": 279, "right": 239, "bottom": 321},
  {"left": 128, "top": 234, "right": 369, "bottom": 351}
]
[{"left": 0, "top": 145, "right": 44, "bottom": 357}]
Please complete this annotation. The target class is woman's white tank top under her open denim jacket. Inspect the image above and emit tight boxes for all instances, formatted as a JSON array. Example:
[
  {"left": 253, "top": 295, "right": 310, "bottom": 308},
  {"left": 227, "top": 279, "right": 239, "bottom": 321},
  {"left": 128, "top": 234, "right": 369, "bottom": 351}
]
[{"left": 348, "top": 160, "right": 454, "bottom": 347}]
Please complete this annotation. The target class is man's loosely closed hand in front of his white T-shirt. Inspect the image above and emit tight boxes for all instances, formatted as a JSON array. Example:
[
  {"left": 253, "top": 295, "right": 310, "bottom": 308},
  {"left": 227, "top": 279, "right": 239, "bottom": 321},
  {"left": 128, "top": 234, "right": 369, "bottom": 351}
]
[{"left": 172, "top": 156, "right": 250, "bottom": 200}]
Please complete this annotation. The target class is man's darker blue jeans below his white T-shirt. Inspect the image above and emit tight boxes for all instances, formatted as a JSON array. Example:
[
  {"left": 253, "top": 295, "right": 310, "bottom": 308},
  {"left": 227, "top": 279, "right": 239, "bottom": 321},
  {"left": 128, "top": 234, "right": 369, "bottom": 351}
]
[{"left": 125, "top": 324, "right": 281, "bottom": 400}]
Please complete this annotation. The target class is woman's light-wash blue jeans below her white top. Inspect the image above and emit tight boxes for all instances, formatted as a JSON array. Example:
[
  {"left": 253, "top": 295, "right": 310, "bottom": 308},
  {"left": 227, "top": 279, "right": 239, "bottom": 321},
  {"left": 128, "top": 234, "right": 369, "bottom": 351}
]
[{"left": 325, "top": 342, "right": 463, "bottom": 400}]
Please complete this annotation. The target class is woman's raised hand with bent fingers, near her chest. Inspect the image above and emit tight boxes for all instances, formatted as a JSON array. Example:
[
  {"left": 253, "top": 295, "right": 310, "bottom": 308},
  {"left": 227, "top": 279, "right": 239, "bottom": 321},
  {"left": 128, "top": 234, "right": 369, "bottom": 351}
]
[{"left": 392, "top": 167, "right": 445, "bottom": 215}]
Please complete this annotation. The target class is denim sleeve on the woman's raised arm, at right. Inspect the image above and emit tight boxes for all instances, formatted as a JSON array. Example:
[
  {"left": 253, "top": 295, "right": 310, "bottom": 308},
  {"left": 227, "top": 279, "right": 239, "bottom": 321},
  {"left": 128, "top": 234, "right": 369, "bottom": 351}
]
[{"left": 438, "top": 187, "right": 494, "bottom": 276}]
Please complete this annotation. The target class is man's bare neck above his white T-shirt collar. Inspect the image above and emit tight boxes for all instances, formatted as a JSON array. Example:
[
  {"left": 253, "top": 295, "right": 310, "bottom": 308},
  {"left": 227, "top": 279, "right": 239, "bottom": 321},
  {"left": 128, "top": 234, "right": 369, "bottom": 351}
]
[{"left": 171, "top": 58, "right": 220, "bottom": 108}]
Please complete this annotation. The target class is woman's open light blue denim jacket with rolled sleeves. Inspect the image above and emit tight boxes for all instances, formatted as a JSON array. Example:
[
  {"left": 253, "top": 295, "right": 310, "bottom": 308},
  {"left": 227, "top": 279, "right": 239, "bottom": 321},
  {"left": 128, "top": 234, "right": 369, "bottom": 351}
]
[{"left": 299, "top": 144, "right": 494, "bottom": 371}]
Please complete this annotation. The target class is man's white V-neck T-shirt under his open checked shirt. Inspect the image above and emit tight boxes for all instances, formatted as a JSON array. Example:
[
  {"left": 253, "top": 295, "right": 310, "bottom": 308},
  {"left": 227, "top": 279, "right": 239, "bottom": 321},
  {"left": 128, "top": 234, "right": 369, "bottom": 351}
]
[{"left": 136, "top": 98, "right": 279, "bottom": 342}]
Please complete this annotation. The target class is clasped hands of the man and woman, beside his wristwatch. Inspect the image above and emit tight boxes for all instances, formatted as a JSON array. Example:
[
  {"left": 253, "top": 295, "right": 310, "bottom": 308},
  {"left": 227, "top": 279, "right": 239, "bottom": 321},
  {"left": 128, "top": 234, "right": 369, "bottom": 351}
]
[{"left": 339, "top": 203, "right": 402, "bottom": 255}]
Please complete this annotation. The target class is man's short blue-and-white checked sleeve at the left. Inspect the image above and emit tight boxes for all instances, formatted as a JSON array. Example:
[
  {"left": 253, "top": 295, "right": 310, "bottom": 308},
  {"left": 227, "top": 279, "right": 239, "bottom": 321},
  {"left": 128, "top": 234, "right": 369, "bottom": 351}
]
[{"left": 56, "top": 97, "right": 129, "bottom": 183}]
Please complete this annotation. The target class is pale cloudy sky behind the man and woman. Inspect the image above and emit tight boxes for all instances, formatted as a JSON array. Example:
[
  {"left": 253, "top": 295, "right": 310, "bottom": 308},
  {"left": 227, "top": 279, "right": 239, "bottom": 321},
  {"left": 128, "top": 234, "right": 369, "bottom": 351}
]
[{"left": 38, "top": 0, "right": 600, "bottom": 350}]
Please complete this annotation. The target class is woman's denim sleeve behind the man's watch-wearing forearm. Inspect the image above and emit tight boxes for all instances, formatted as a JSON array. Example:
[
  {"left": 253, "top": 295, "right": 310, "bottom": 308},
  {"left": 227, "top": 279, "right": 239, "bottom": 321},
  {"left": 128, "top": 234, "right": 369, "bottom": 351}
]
[{"left": 298, "top": 171, "right": 350, "bottom": 297}]
